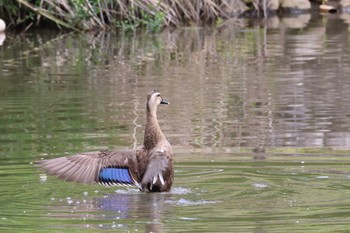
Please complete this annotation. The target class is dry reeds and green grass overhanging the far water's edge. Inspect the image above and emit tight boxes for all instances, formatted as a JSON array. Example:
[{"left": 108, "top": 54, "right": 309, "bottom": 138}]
[{"left": 0, "top": 0, "right": 249, "bottom": 31}]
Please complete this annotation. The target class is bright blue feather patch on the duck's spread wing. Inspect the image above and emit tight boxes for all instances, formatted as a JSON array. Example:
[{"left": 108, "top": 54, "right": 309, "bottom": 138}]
[{"left": 99, "top": 167, "right": 133, "bottom": 184}]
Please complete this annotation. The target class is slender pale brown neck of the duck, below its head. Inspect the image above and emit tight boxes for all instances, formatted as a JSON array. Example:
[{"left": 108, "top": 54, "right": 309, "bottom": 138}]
[{"left": 143, "top": 108, "right": 166, "bottom": 150}]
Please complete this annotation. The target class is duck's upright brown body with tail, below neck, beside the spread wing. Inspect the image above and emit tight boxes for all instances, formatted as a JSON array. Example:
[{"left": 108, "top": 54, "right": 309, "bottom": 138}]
[{"left": 141, "top": 149, "right": 173, "bottom": 191}]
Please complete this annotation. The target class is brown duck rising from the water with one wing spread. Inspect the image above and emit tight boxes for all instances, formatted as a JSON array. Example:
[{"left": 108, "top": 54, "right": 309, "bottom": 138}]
[{"left": 39, "top": 90, "right": 174, "bottom": 192}]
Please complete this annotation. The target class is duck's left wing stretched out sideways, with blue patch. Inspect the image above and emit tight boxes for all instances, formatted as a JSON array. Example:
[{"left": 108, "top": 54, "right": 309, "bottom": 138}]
[{"left": 40, "top": 150, "right": 139, "bottom": 186}]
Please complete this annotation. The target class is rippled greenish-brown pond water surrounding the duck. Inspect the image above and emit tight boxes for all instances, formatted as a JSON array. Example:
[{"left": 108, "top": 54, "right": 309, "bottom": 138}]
[{"left": 0, "top": 12, "right": 350, "bottom": 233}]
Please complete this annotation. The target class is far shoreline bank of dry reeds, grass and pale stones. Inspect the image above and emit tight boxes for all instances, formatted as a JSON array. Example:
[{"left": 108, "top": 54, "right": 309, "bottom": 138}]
[{"left": 0, "top": 0, "right": 348, "bottom": 31}]
